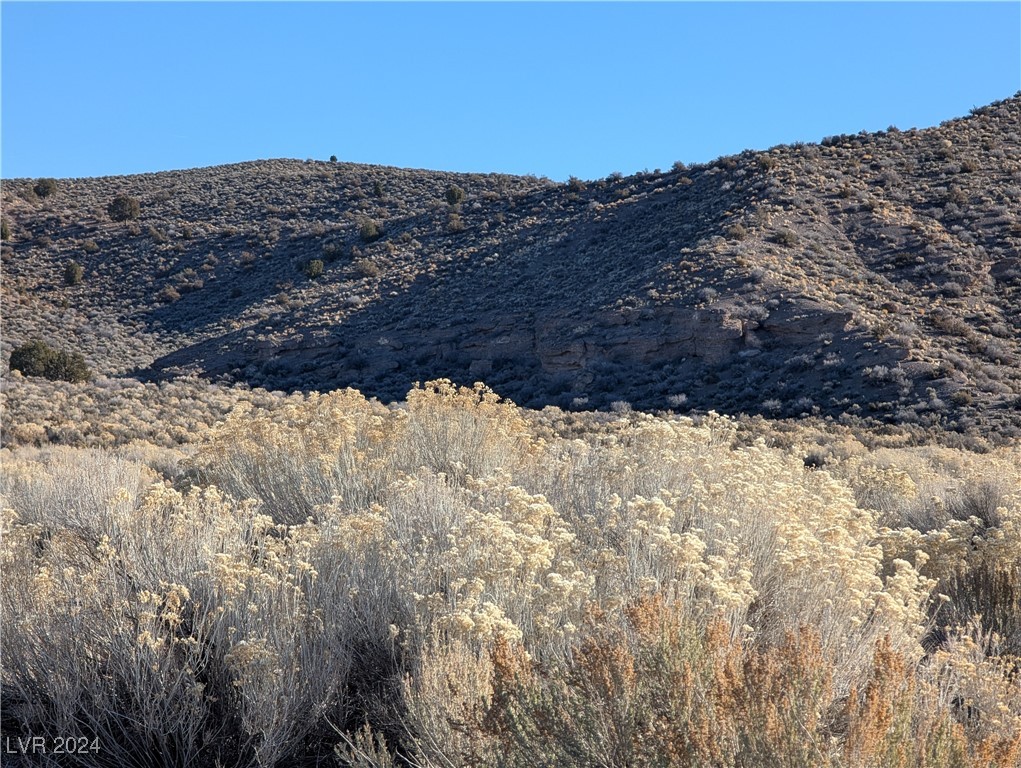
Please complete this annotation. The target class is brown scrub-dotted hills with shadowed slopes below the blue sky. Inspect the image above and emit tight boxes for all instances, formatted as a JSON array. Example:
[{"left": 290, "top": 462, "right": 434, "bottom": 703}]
[{"left": 2, "top": 96, "right": 1021, "bottom": 439}]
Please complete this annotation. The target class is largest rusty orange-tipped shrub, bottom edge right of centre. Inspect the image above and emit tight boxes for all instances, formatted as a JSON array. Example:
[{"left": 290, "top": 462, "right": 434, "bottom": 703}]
[{"left": 469, "top": 612, "right": 832, "bottom": 766}]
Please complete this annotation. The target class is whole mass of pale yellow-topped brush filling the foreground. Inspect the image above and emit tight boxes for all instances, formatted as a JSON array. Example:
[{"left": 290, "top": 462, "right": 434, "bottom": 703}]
[{"left": 0, "top": 381, "right": 1021, "bottom": 768}]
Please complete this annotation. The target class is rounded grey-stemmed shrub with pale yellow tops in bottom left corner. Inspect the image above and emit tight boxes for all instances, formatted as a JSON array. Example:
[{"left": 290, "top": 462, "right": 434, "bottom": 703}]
[{"left": 2, "top": 469, "right": 355, "bottom": 768}]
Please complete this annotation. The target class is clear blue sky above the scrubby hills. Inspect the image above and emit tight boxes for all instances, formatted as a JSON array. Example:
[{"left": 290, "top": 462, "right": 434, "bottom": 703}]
[{"left": 0, "top": 2, "right": 1021, "bottom": 180}]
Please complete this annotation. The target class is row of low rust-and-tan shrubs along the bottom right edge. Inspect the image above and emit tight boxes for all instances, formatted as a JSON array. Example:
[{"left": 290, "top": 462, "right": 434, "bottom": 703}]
[{"left": 402, "top": 597, "right": 1021, "bottom": 768}]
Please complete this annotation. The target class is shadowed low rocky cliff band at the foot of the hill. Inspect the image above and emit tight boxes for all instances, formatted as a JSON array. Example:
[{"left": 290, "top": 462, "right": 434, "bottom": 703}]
[{"left": 139, "top": 285, "right": 906, "bottom": 422}]
